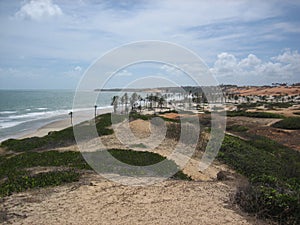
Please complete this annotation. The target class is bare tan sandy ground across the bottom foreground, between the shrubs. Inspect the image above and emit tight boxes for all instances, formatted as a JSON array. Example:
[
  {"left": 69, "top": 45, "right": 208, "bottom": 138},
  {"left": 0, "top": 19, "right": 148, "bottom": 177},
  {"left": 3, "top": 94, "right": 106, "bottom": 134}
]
[{"left": 2, "top": 175, "right": 261, "bottom": 224}]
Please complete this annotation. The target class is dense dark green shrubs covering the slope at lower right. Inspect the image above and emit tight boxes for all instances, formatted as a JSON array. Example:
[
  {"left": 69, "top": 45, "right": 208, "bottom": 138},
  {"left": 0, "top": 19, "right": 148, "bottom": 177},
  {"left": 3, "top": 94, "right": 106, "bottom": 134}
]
[{"left": 218, "top": 136, "right": 300, "bottom": 224}]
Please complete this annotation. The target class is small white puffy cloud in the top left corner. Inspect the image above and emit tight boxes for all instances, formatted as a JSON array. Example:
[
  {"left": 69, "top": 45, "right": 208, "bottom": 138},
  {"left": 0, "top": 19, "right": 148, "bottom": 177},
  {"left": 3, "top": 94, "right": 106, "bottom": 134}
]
[{"left": 15, "top": 0, "right": 63, "bottom": 20}]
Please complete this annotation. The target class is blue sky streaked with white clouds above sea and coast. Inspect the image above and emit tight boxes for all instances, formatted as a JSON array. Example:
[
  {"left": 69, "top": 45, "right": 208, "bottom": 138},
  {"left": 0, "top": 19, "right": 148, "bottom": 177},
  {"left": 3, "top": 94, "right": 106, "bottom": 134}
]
[{"left": 0, "top": 0, "right": 300, "bottom": 89}]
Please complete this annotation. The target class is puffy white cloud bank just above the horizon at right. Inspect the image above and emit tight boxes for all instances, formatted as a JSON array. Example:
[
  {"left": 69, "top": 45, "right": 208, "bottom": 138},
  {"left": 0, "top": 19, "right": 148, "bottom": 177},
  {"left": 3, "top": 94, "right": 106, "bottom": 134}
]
[{"left": 211, "top": 49, "right": 300, "bottom": 84}]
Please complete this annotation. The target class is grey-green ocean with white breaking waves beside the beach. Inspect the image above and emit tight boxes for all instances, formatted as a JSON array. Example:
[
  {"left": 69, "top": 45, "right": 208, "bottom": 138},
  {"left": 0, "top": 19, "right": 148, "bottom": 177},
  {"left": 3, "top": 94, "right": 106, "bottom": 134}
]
[{"left": 0, "top": 90, "right": 118, "bottom": 141}]
